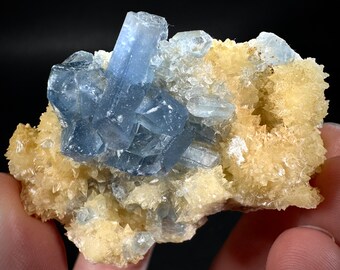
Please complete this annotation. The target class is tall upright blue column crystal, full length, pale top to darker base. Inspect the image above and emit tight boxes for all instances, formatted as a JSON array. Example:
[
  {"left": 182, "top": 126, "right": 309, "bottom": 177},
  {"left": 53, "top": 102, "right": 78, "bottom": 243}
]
[{"left": 93, "top": 12, "right": 168, "bottom": 150}]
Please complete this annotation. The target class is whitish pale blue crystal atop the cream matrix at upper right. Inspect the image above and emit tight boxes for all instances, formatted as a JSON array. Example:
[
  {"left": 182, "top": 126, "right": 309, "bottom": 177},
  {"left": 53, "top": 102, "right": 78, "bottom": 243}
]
[{"left": 249, "top": 32, "right": 301, "bottom": 66}]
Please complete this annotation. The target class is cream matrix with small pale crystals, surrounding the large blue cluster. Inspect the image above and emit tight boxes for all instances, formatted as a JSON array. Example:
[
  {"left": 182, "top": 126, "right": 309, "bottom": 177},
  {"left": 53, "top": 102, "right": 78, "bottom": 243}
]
[{"left": 6, "top": 12, "right": 328, "bottom": 266}]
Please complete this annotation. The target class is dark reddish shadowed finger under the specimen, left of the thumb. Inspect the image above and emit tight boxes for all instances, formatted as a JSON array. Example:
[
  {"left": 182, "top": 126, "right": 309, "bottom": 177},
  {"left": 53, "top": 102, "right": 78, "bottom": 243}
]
[{"left": 212, "top": 208, "right": 300, "bottom": 270}]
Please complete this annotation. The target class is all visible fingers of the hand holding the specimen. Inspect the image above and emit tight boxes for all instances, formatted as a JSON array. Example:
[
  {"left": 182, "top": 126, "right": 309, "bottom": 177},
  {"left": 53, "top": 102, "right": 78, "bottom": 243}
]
[{"left": 0, "top": 123, "right": 340, "bottom": 270}]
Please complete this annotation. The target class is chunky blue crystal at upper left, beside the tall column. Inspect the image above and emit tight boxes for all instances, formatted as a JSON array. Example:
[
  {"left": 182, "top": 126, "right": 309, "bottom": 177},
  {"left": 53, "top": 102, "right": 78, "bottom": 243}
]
[{"left": 47, "top": 51, "right": 107, "bottom": 123}]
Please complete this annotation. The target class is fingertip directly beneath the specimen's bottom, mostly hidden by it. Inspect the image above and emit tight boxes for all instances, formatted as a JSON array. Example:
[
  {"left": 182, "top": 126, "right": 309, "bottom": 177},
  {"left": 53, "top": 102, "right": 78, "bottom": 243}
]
[{"left": 74, "top": 247, "right": 152, "bottom": 270}]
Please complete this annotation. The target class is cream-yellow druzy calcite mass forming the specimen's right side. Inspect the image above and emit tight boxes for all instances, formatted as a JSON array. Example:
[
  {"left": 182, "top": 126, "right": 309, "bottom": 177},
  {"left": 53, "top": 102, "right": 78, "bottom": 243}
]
[{"left": 206, "top": 40, "right": 328, "bottom": 209}]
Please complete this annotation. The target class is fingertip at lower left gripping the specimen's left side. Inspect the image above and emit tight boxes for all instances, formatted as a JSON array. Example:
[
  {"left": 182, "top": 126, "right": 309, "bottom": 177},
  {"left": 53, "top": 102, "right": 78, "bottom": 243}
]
[{"left": 0, "top": 174, "right": 67, "bottom": 270}]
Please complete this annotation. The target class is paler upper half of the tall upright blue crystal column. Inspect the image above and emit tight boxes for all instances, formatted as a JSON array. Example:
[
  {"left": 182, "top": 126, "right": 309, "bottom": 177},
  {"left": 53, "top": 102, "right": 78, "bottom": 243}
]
[{"left": 106, "top": 12, "right": 168, "bottom": 85}]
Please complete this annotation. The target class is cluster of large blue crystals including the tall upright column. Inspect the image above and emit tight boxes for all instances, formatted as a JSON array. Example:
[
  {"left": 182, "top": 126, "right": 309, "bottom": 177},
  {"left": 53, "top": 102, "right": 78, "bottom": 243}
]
[{"left": 48, "top": 12, "right": 222, "bottom": 175}]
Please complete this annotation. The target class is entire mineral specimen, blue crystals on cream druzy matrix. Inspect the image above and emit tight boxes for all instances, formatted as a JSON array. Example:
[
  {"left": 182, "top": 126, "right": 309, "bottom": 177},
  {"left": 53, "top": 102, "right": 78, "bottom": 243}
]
[{"left": 6, "top": 12, "right": 328, "bottom": 266}]
